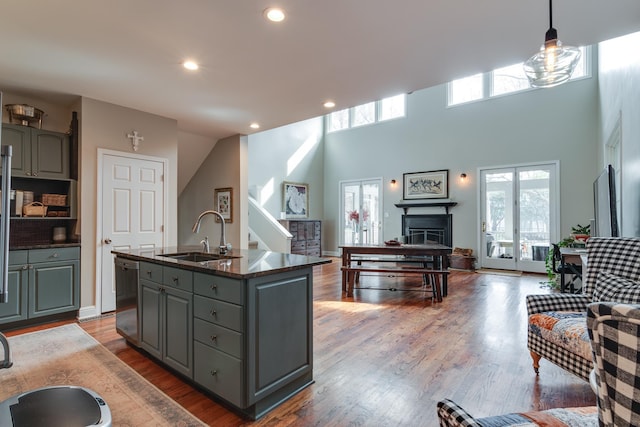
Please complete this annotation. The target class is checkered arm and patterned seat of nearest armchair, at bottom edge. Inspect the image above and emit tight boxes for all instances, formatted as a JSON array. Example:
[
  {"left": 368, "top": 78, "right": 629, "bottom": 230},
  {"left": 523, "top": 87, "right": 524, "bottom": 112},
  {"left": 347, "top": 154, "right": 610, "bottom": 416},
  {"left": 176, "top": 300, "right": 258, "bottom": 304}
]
[{"left": 438, "top": 399, "right": 598, "bottom": 427}]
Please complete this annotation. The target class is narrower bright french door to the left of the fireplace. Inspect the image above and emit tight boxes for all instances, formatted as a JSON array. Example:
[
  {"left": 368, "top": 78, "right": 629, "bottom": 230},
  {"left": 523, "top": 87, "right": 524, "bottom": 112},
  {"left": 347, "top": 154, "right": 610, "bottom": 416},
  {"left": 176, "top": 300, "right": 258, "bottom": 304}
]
[{"left": 339, "top": 178, "right": 382, "bottom": 245}]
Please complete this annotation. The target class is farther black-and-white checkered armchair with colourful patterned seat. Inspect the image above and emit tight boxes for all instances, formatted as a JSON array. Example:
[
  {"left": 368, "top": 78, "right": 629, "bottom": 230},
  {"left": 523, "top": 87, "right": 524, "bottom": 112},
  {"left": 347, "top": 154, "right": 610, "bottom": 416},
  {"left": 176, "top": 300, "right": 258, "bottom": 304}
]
[{"left": 526, "top": 237, "right": 640, "bottom": 381}]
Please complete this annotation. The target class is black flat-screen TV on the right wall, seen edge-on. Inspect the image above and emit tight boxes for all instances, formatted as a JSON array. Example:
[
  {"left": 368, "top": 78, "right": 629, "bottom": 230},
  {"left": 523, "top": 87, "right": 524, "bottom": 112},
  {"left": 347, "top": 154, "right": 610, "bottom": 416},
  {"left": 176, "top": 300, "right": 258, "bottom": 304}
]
[{"left": 591, "top": 165, "right": 620, "bottom": 237}]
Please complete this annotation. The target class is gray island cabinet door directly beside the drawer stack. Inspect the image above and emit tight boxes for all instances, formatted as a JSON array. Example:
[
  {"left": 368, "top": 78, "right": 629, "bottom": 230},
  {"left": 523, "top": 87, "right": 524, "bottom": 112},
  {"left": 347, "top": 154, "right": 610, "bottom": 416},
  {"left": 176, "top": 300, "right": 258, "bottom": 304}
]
[{"left": 162, "top": 287, "right": 193, "bottom": 378}]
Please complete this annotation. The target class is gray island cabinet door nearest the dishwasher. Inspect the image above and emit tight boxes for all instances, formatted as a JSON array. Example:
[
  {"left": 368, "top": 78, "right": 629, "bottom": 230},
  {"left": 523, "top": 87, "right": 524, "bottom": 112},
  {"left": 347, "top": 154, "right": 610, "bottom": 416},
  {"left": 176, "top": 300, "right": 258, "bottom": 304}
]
[{"left": 138, "top": 280, "right": 162, "bottom": 360}]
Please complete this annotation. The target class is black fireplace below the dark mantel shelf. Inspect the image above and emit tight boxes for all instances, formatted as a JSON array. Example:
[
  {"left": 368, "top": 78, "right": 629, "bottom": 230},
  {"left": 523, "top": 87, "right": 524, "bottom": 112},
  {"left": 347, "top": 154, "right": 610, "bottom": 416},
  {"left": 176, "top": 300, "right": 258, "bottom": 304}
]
[{"left": 402, "top": 214, "right": 453, "bottom": 247}]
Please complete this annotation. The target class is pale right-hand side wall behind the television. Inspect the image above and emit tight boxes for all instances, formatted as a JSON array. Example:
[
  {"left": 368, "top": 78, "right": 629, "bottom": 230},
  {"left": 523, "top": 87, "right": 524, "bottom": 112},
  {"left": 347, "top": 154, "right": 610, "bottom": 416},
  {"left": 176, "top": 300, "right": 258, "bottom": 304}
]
[{"left": 598, "top": 32, "right": 640, "bottom": 236}]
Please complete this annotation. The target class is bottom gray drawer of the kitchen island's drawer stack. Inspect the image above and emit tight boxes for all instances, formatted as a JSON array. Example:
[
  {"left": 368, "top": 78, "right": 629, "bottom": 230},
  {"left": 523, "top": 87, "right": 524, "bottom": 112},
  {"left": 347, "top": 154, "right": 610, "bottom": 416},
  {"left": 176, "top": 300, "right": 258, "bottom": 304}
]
[{"left": 193, "top": 341, "right": 246, "bottom": 408}]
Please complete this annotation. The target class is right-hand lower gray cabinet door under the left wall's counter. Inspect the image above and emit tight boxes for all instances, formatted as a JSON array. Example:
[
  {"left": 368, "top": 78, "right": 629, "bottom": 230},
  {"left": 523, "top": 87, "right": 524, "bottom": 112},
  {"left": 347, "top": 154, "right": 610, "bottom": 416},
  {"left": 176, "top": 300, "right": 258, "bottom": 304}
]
[{"left": 29, "top": 261, "right": 80, "bottom": 317}]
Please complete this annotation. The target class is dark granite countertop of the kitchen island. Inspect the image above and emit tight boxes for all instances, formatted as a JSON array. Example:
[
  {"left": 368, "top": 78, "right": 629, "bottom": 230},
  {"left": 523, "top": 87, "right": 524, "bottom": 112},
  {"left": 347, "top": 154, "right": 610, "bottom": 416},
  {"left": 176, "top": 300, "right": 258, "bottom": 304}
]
[{"left": 111, "top": 246, "right": 331, "bottom": 279}]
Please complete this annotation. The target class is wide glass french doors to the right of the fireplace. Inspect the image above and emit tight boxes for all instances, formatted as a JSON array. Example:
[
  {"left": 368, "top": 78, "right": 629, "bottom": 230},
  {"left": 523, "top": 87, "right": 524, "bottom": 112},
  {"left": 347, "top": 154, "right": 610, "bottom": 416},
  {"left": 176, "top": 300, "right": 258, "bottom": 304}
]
[{"left": 479, "top": 162, "right": 559, "bottom": 273}]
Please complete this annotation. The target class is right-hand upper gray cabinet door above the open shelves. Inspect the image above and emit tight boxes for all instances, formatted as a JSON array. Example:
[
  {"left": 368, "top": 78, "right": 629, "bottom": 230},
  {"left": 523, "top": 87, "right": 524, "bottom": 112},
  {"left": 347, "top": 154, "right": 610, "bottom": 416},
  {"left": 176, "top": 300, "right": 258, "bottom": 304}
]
[{"left": 31, "top": 129, "right": 69, "bottom": 179}]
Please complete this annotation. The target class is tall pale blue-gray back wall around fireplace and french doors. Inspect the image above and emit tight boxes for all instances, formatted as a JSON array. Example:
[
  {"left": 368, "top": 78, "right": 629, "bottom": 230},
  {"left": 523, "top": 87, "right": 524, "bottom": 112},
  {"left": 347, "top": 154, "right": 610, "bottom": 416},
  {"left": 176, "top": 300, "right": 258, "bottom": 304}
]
[{"left": 324, "top": 78, "right": 598, "bottom": 254}]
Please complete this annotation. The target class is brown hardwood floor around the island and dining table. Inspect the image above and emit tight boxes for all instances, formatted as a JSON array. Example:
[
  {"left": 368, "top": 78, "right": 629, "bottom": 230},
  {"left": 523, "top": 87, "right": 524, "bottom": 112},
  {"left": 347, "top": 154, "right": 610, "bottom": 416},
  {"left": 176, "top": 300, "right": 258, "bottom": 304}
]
[{"left": 7, "top": 259, "right": 595, "bottom": 426}]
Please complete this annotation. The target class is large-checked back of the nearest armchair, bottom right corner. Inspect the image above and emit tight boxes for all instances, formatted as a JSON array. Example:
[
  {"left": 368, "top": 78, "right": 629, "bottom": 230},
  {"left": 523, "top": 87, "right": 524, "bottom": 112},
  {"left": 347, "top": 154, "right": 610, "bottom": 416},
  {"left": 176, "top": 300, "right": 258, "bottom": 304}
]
[{"left": 587, "top": 303, "right": 640, "bottom": 427}]
